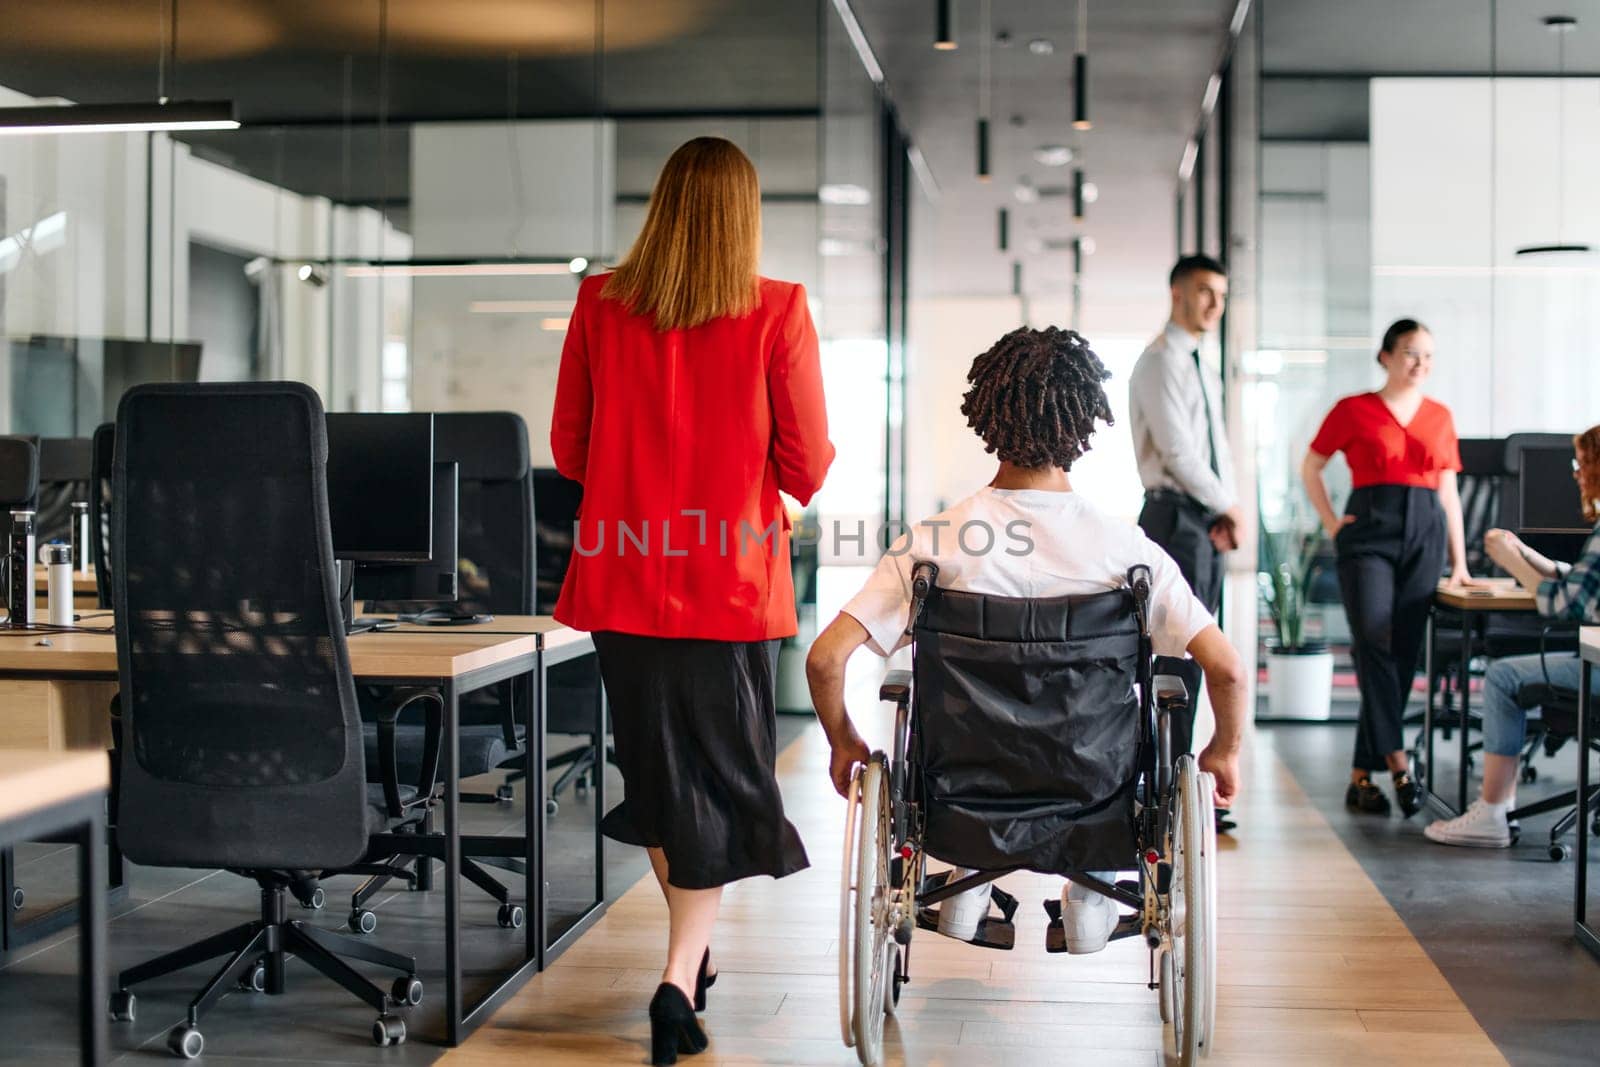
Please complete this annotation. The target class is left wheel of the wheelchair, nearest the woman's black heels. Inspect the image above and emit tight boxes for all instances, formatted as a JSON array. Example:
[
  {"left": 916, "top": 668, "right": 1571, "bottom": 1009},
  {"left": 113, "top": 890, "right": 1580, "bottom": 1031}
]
[{"left": 838, "top": 753, "right": 894, "bottom": 1067}]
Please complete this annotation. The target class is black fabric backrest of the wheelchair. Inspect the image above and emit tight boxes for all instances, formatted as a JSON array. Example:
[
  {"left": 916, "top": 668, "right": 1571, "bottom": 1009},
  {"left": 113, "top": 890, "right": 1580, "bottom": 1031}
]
[{"left": 912, "top": 589, "right": 1149, "bottom": 873}]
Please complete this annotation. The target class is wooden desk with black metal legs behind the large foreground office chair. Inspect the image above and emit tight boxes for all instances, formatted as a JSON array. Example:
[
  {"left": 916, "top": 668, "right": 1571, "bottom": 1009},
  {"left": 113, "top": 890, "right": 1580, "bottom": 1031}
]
[{"left": 0, "top": 616, "right": 605, "bottom": 1045}]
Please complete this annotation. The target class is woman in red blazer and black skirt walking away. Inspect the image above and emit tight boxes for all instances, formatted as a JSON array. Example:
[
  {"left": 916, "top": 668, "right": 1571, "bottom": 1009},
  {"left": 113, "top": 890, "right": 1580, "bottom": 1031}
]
[{"left": 550, "top": 138, "right": 832, "bottom": 1064}]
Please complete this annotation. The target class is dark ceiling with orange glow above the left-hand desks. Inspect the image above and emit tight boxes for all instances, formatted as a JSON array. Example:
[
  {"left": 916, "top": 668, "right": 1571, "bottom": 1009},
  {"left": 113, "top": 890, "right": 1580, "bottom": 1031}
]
[{"left": 0, "top": 0, "right": 826, "bottom": 205}]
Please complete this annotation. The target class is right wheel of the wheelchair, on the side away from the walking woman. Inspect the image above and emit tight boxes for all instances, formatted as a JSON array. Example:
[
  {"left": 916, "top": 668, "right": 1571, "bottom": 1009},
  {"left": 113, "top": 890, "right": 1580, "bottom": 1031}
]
[{"left": 1160, "top": 755, "right": 1216, "bottom": 1067}]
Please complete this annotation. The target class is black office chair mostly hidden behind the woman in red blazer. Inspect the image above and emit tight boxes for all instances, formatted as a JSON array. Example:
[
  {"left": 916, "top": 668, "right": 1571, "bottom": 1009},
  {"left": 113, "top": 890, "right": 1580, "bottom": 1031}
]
[{"left": 533, "top": 467, "right": 616, "bottom": 814}]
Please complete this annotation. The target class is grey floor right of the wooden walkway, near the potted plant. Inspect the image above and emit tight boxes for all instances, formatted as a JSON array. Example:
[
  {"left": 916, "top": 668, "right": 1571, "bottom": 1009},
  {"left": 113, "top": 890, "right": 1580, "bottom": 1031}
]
[{"left": 1260, "top": 725, "right": 1600, "bottom": 1067}]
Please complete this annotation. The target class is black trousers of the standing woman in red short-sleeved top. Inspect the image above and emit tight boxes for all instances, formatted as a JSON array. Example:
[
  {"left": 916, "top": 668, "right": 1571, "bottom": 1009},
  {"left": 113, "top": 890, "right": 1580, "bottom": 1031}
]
[{"left": 1334, "top": 485, "right": 1448, "bottom": 771}]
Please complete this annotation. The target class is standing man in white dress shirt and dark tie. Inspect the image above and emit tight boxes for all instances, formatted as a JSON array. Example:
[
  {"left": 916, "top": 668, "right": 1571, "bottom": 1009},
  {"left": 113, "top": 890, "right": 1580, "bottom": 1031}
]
[{"left": 1128, "top": 256, "right": 1243, "bottom": 819}]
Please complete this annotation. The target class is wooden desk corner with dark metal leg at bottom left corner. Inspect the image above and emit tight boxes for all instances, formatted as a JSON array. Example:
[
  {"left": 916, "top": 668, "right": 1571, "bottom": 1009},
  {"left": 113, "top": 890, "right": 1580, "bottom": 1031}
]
[{"left": 0, "top": 749, "right": 110, "bottom": 1064}]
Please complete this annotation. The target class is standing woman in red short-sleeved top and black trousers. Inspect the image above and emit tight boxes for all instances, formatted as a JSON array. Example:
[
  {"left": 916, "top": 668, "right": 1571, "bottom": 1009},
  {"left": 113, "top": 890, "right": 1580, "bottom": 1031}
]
[{"left": 1301, "top": 318, "right": 1469, "bottom": 817}]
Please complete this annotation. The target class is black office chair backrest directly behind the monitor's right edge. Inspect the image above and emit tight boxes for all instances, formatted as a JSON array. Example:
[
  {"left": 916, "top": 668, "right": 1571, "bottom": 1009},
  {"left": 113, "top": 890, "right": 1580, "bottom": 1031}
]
[{"left": 434, "top": 411, "right": 534, "bottom": 614}]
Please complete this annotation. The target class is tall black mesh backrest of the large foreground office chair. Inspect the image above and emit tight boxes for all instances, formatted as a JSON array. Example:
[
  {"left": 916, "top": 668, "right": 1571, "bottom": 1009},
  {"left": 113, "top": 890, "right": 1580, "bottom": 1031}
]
[{"left": 112, "top": 382, "right": 366, "bottom": 870}]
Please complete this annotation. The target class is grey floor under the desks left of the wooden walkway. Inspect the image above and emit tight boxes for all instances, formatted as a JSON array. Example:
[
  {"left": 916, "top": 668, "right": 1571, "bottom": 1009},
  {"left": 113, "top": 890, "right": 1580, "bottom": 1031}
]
[{"left": 0, "top": 715, "right": 814, "bottom": 1067}]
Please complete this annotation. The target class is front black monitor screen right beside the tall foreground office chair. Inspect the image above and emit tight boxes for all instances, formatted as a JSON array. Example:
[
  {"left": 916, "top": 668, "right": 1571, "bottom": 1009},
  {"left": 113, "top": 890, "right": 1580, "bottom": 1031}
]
[{"left": 328, "top": 414, "right": 434, "bottom": 563}]
